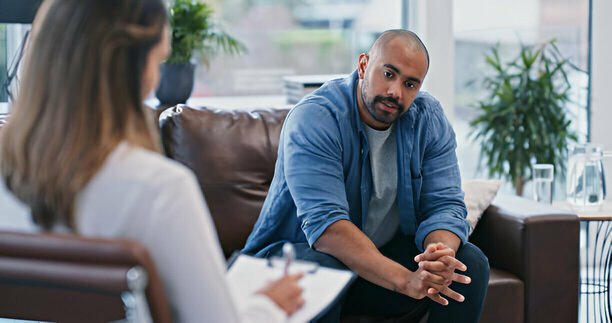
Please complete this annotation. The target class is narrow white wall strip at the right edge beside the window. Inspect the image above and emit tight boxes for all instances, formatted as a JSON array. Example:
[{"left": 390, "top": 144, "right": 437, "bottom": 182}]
[{"left": 591, "top": 0, "right": 612, "bottom": 196}]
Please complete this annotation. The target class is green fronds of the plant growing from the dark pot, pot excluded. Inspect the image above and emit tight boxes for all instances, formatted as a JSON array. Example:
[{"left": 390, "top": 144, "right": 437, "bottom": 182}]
[{"left": 167, "top": 0, "right": 246, "bottom": 66}]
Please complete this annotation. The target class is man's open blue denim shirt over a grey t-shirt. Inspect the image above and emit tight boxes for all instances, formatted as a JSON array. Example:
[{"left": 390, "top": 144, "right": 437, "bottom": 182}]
[{"left": 243, "top": 71, "right": 468, "bottom": 254}]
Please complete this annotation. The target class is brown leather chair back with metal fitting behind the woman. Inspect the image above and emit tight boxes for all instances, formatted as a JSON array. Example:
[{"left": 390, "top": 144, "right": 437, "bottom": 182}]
[{"left": 0, "top": 231, "right": 171, "bottom": 322}]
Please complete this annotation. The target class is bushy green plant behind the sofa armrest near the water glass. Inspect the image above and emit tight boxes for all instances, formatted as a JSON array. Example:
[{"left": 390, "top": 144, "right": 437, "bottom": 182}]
[{"left": 470, "top": 40, "right": 579, "bottom": 195}]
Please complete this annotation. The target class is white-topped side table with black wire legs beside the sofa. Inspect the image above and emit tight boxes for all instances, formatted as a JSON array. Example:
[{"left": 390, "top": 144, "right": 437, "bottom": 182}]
[{"left": 553, "top": 201, "right": 612, "bottom": 323}]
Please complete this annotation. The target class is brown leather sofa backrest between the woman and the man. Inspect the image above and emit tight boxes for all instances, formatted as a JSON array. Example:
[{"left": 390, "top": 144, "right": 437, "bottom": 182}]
[{"left": 160, "top": 105, "right": 289, "bottom": 257}]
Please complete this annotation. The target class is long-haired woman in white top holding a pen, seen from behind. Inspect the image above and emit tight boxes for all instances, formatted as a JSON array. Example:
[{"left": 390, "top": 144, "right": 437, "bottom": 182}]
[{"left": 0, "top": 0, "right": 303, "bottom": 322}]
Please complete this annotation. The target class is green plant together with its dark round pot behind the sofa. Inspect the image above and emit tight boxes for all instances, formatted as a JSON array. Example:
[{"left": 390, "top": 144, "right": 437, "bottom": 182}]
[{"left": 155, "top": 0, "right": 246, "bottom": 105}]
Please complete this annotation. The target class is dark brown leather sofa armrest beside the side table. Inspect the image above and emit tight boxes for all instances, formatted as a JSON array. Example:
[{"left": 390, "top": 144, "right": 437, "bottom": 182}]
[{"left": 470, "top": 196, "right": 580, "bottom": 323}]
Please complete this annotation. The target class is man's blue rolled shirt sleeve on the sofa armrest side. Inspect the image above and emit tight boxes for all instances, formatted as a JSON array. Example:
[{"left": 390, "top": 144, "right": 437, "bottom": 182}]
[{"left": 415, "top": 103, "right": 469, "bottom": 251}]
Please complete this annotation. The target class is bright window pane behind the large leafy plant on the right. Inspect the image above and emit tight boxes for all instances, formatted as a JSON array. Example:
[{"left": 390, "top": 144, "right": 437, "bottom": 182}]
[{"left": 453, "top": 0, "right": 590, "bottom": 180}]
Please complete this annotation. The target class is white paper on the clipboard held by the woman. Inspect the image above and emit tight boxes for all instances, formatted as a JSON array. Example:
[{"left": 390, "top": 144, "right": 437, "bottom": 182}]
[{"left": 227, "top": 255, "right": 355, "bottom": 323}]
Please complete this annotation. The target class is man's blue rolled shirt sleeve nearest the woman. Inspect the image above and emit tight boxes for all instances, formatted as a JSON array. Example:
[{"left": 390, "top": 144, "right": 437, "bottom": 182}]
[{"left": 282, "top": 104, "right": 350, "bottom": 247}]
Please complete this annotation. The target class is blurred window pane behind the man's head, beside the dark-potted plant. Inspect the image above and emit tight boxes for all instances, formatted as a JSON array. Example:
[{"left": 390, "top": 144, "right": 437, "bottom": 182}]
[{"left": 193, "top": 0, "right": 407, "bottom": 97}]
